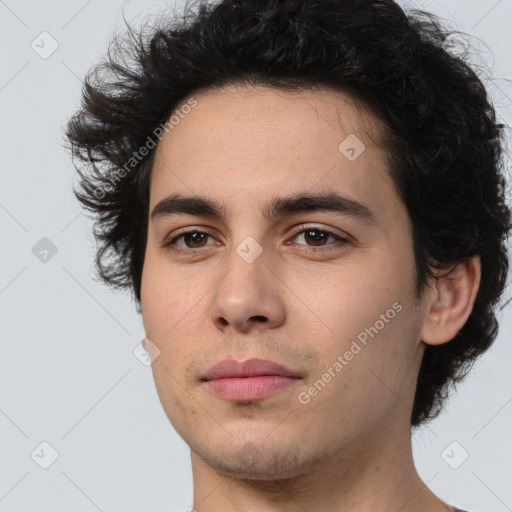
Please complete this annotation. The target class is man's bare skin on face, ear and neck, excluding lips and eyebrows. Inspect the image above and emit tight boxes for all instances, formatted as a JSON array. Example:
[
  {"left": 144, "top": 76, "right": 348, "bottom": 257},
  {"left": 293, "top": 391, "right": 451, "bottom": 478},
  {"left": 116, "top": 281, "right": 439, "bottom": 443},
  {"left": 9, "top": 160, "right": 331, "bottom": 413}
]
[{"left": 141, "top": 84, "right": 480, "bottom": 512}]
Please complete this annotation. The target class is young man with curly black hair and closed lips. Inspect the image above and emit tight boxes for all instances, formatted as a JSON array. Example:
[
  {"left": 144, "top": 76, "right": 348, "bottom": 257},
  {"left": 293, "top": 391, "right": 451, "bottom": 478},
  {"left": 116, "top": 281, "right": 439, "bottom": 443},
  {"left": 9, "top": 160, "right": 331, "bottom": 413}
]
[{"left": 68, "top": 0, "right": 510, "bottom": 512}]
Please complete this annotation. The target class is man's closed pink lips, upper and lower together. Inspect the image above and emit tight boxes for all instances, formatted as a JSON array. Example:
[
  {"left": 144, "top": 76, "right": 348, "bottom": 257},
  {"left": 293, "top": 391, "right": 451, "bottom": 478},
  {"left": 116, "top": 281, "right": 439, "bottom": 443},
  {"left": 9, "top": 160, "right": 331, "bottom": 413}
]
[{"left": 202, "top": 359, "right": 302, "bottom": 401}]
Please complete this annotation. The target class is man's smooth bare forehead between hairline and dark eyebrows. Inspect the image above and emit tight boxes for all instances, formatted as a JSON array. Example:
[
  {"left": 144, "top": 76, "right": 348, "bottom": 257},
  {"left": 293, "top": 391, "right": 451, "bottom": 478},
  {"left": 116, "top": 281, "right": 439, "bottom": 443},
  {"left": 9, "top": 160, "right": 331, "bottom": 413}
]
[{"left": 150, "top": 84, "right": 396, "bottom": 222}]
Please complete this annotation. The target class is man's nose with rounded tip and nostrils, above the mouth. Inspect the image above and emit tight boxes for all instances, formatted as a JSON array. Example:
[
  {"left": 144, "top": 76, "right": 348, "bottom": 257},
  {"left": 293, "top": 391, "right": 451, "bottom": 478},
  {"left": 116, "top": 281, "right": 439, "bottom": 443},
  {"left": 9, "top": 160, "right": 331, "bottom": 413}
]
[{"left": 210, "top": 245, "right": 286, "bottom": 333}]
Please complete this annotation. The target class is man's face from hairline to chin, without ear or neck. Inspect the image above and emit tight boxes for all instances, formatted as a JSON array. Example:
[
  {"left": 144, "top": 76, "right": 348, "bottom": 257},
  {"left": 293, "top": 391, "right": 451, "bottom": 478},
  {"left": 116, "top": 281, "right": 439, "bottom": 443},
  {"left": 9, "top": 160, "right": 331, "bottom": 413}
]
[{"left": 141, "top": 85, "right": 432, "bottom": 479}]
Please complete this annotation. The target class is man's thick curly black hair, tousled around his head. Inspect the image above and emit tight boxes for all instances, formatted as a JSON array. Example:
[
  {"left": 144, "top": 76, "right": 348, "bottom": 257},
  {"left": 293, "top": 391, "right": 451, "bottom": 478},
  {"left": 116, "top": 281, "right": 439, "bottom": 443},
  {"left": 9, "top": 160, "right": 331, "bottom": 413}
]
[{"left": 66, "top": 0, "right": 512, "bottom": 427}]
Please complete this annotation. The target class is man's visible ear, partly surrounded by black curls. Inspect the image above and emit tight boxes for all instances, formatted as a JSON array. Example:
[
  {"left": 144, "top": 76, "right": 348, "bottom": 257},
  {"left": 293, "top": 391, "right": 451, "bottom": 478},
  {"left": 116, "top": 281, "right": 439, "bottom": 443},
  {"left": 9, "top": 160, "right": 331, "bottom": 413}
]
[{"left": 420, "top": 255, "right": 481, "bottom": 345}]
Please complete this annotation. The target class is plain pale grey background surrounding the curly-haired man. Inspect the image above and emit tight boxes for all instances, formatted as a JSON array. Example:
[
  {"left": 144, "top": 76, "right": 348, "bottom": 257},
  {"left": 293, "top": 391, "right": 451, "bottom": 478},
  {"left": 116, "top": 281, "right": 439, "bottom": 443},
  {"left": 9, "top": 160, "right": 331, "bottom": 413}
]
[{"left": 0, "top": 0, "right": 512, "bottom": 512}]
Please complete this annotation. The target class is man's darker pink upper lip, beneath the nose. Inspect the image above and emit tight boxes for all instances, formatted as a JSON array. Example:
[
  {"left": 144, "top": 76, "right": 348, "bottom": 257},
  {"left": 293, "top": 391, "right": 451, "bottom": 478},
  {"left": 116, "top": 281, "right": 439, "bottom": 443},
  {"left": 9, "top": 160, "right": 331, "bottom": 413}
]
[{"left": 202, "top": 359, "right": 300, "bottom": 380}]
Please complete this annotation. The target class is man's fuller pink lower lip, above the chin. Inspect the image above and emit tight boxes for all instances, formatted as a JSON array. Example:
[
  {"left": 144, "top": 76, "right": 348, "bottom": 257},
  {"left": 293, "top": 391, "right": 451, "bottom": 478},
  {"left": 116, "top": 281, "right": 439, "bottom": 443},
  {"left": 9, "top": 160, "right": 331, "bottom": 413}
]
[{"left": 206, "top": 375, "right": 299, "bottom": 401}]
